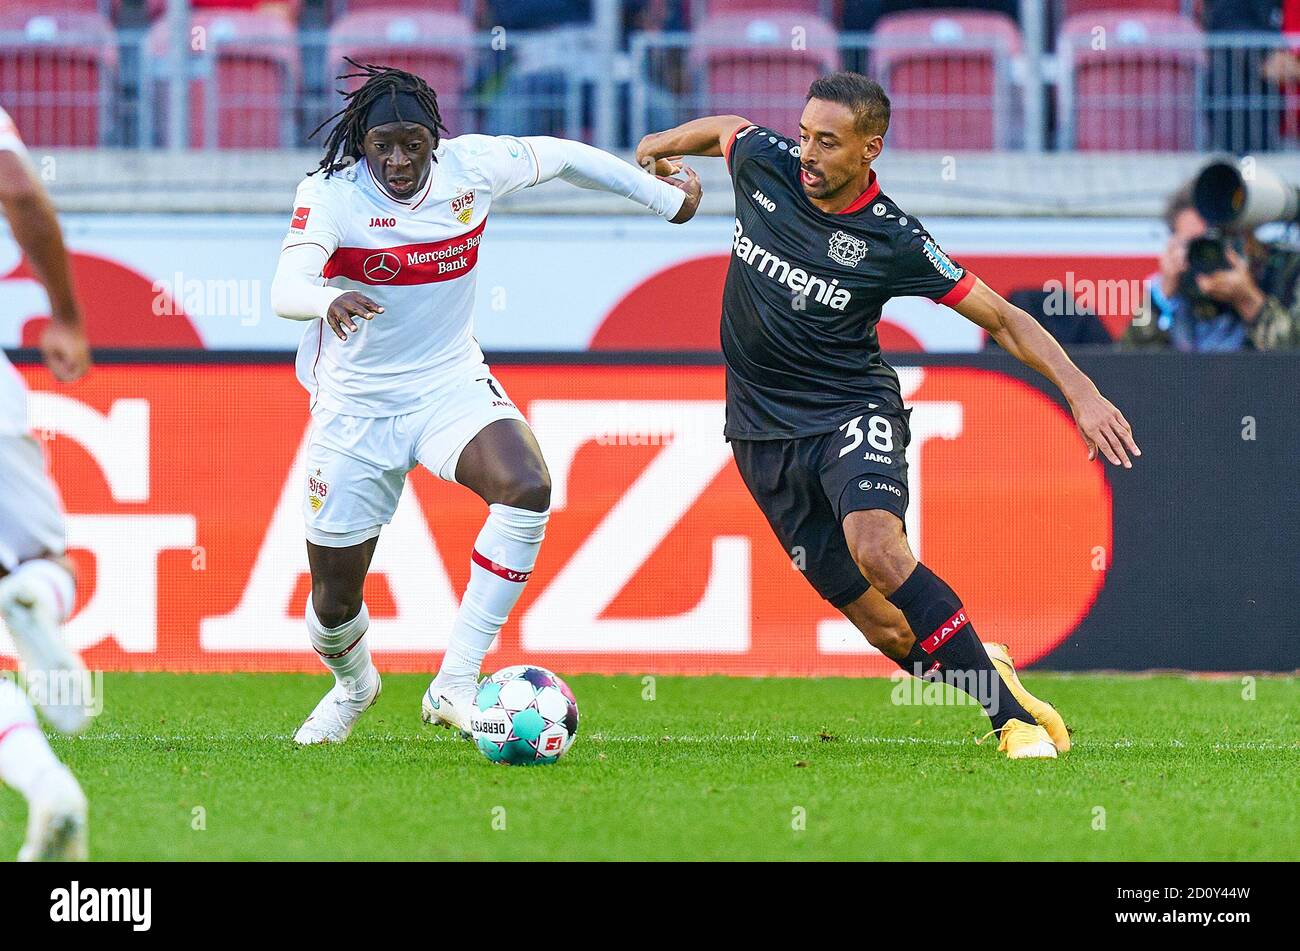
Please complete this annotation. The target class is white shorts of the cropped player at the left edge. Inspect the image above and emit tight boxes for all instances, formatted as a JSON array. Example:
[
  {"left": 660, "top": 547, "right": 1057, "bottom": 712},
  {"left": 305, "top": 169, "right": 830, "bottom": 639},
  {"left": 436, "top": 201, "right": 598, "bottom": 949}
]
[{"left": 0, "top": 435, "right": 66, "bottom": 572}]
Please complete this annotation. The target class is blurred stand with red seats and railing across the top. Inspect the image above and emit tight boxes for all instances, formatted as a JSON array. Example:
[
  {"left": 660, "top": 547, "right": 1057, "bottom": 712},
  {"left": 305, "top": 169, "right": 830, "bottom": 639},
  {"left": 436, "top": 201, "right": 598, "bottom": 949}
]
[{"left": 0, "top": 0, "right": 1300, "bottom": 152}]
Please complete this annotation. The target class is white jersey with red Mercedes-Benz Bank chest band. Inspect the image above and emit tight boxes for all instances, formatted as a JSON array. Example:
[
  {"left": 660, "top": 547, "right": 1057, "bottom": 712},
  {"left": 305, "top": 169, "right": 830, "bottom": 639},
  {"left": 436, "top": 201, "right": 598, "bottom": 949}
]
[{"left": 281, "top": 135, "right": 540, "bottom": 417}]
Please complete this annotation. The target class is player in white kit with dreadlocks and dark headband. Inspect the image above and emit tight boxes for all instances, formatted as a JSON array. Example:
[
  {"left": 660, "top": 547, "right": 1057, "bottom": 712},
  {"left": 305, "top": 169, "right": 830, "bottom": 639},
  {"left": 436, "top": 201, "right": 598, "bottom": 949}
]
[{"left": 272, "top": 64, "right": 701, "bottom": 744}]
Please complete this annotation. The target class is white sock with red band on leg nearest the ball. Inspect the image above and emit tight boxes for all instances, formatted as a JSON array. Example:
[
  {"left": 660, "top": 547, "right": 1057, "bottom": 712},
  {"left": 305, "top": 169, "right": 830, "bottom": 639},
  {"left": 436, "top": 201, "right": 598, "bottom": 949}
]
[{"left": 437, "top": 503, "right": 550, "bottom": 685}]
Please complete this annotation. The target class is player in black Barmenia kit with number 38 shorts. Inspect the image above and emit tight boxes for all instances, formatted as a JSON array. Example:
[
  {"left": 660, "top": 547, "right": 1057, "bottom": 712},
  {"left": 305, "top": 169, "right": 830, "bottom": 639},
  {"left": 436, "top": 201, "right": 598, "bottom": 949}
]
[{"left": 637, "top": 73, "right": 1141, "bottom": 759}]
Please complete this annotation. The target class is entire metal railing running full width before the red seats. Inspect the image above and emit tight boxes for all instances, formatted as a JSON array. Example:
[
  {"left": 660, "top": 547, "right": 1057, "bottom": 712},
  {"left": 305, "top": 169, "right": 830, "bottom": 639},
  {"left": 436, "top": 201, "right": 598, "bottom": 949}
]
[{"left": 0, "top": 8, "right": 1300, "bottom": 152}]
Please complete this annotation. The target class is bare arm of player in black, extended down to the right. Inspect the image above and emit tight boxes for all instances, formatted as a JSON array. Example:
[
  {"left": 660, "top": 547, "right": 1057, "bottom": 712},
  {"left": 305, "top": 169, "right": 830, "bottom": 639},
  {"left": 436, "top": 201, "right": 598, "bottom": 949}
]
[{"left": 954, "top": 279, "right": 1141, "bottom": 469}]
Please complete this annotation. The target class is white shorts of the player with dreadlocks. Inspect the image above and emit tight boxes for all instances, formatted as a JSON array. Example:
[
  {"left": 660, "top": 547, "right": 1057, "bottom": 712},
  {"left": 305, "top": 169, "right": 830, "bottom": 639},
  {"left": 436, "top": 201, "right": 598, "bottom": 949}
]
[{"left": 303, "top": 364, "right": 525, "bottom": 548}]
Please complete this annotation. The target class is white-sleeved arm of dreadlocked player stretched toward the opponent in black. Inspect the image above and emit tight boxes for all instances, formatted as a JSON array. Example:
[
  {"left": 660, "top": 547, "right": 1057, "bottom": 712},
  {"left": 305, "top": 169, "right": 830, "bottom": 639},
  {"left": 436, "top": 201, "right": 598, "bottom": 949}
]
[{"left": 523, "top": 135, "right": 703, "bottom": 225}]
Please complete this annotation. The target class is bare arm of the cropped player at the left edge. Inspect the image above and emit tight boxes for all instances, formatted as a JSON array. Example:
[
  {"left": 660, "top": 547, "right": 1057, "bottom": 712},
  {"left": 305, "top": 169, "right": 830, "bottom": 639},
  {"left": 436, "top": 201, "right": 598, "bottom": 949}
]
[{"left": 0, "top": 149, "right": 90, "bottom": 383}]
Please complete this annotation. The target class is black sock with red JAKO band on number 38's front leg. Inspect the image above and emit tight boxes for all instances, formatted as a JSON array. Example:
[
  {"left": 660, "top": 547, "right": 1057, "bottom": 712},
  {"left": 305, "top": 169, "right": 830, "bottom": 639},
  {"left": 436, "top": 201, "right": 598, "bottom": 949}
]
[{"left": 888, "top": 561, "right": 1034, "bottom": 730}]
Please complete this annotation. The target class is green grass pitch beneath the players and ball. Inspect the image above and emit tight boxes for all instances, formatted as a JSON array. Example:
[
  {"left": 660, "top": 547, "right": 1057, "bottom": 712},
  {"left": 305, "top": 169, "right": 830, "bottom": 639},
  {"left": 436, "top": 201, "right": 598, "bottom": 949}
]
[{"left": 0, "top": 673, "right": 1300, "bottom": 860}]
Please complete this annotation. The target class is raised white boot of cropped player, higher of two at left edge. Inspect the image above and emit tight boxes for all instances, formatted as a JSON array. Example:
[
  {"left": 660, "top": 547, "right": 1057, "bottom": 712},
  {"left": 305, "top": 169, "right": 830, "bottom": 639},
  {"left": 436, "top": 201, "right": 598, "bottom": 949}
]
[{"left": 0, "top": 574, "right": 94, "bottom": 734}]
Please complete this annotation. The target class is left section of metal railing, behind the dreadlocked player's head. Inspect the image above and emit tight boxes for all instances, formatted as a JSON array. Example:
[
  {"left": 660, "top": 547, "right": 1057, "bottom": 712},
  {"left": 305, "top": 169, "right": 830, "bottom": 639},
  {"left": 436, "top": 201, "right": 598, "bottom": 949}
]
[{"left": 0, "top": 23, "right": 602, "bottom": 148}]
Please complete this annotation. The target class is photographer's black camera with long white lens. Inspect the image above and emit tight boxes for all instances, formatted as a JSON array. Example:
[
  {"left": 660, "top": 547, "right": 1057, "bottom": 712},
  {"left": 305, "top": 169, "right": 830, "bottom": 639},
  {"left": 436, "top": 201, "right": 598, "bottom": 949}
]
[{"left": 1178, "top": 157, "right": 1300, "bottom": 320}]
